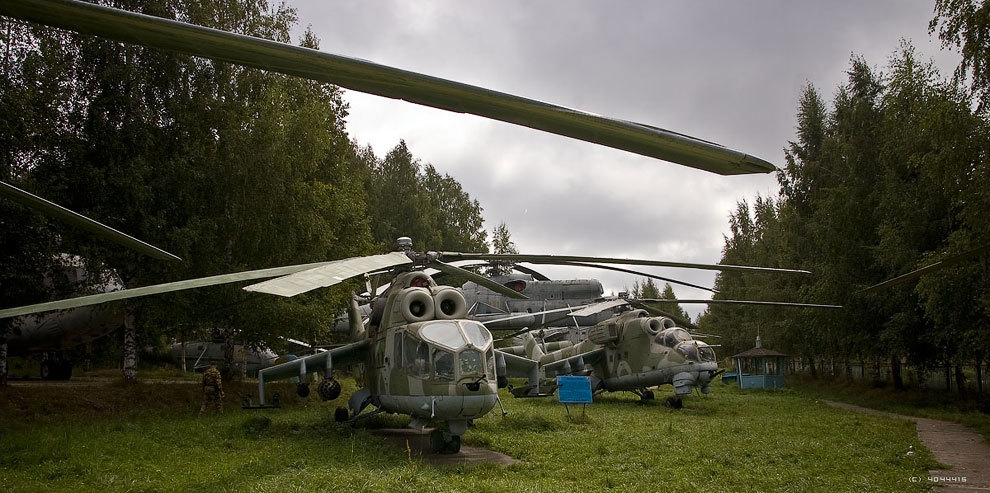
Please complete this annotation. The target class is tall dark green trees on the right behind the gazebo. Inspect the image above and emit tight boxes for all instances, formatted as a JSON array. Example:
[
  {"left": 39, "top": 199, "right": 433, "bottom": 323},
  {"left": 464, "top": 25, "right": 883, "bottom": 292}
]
[{"left": 699, "top": 20, "right": 990, "bottom": 389}]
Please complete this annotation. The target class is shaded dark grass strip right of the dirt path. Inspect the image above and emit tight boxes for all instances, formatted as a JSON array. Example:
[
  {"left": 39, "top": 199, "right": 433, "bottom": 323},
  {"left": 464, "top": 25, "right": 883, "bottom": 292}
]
[{"left": 787, "top": 375, "right": 990, "bottom": 441}]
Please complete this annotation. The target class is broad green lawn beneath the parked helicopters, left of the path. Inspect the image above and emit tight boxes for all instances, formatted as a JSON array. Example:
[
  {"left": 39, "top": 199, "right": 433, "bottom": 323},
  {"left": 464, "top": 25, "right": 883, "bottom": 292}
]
[{"left": 0, "top": 380, "right": 938, "bottom": 492}]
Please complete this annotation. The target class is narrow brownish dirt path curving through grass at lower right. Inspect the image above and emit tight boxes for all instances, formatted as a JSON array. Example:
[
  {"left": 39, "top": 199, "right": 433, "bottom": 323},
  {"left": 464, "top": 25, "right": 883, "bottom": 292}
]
[{"left": 825, "top": 401, "right": 990, "bottom": 493}]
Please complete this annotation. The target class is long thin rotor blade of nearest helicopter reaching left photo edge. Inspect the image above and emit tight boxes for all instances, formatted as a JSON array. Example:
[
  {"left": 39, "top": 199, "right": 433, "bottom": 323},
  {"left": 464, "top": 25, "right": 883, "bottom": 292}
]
[{"left": 0, "top": 262, "right": 340, "bottom": 318}]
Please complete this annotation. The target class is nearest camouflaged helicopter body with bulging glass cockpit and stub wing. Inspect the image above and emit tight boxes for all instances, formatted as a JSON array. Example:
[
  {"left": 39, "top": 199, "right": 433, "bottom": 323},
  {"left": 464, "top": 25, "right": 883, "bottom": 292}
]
[{"left": 258, "top": 262, "right": 498, "bottom": 453}]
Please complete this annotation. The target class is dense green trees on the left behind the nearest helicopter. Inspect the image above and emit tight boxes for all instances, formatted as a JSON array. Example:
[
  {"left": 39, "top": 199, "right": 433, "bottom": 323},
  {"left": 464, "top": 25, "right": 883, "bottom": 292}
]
[{"left": 0, "top": 0, "right": 487, "bottom": 378}]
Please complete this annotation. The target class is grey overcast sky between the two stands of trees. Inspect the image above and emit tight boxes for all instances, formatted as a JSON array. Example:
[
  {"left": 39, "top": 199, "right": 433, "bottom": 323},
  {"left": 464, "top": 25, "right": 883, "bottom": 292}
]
[{"left": 288, "top": 0, "right": 958, "bottom": 314}]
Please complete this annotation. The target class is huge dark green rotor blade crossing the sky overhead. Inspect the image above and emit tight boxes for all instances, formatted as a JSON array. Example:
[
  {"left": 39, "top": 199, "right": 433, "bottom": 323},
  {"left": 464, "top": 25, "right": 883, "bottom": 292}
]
[{"left": 0, "top": 0, "right": 776, "bottom": 175}]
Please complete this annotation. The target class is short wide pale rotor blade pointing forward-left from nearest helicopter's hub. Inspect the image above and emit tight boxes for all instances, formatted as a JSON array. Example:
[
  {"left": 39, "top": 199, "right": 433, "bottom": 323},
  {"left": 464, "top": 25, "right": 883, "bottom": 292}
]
[{"left": 244, "top": 252, "right": 412, "bottom": 297}]
